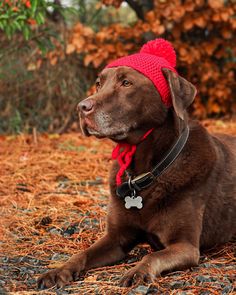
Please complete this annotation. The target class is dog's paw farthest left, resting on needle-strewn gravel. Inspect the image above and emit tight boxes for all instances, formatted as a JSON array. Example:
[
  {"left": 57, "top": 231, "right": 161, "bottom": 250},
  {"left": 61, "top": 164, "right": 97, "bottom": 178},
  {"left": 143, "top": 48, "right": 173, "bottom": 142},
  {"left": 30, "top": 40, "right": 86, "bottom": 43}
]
[{"left": 37, "top": 267, "right": 75, "bottom": 290}]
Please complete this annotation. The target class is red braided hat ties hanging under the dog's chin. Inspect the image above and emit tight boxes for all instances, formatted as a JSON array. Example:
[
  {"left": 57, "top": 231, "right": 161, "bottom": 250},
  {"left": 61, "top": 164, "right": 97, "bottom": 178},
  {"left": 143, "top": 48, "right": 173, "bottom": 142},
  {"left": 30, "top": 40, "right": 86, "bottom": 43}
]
[{"left": 112, "top": 128, "right": 153, "bottom": 186}]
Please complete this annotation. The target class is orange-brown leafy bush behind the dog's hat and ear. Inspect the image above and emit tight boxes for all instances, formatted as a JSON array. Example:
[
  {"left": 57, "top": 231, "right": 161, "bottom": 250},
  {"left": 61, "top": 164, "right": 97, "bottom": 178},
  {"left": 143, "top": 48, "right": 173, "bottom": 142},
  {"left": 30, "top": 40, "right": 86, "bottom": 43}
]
[{"left": 64, "top": 0, "right": 236, "bottom": 118}]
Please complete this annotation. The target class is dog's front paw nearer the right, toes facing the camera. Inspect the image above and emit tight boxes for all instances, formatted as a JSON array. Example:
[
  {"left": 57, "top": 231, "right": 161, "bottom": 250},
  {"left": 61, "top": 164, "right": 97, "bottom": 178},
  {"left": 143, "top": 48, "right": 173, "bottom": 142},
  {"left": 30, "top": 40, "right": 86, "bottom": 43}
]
[{"left": 120, "top": 267, "right": 155, "bottom": 287}]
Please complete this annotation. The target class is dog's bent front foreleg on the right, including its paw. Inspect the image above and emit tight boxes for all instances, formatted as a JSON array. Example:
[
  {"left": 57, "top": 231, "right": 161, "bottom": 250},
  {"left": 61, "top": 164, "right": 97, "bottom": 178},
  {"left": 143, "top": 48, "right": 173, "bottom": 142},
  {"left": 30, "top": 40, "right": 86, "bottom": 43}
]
[{"left": 121, "top": 242, "right": 199, "bottom": 287}]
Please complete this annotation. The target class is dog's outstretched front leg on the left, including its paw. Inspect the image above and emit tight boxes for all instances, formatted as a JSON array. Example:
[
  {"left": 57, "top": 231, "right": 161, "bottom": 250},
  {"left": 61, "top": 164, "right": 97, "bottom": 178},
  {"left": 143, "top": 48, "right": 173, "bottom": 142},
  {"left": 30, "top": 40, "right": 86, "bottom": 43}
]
[{"left": 38, "top": 234, "right": 132, "bottom": 289}]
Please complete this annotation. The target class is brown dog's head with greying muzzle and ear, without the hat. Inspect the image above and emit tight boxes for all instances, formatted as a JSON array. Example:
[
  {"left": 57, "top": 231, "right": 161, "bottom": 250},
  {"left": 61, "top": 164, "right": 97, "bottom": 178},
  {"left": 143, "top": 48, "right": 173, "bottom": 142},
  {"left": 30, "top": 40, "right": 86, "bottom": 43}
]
[{"left": 78, "top": 66, "right": 196, "bottom": 141}]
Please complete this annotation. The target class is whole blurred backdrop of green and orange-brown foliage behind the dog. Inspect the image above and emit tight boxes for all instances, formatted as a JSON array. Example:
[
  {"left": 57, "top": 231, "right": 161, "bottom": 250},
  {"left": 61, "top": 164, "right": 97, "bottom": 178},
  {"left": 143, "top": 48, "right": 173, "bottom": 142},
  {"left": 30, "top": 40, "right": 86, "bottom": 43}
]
[{"left": 0, "top": 0, "right": 236, "bottom": 133}]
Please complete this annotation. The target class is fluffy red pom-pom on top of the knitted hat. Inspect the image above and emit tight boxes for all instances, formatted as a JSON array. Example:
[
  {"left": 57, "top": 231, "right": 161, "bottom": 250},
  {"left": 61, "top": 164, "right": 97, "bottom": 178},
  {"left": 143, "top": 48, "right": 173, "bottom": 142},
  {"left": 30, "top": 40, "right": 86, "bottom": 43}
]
[{"left": 140, "top": 38, "right": 176, "bottom": 68}]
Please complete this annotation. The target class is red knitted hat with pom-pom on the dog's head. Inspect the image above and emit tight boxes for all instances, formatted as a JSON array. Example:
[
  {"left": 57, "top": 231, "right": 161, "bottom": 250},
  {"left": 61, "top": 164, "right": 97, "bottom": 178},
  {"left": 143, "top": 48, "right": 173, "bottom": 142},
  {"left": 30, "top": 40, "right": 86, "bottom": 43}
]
[{"left": 106, "top": 38, "right": 176, "bottom": 107}]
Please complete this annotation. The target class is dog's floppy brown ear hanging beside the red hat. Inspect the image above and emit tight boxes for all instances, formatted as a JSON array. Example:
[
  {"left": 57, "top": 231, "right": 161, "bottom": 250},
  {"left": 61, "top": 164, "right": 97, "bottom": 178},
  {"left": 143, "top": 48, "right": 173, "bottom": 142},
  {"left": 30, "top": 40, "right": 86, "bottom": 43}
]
[{"left": 162, "top": 68, "right": 197, "bottom": 120}]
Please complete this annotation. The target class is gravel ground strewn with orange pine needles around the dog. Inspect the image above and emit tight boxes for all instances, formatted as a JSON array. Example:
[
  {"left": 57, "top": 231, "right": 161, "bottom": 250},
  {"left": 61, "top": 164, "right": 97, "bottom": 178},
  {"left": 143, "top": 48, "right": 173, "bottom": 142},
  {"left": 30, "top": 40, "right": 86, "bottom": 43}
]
[{"left": 0, "top": 120, "right": 236, "bottom": 295}]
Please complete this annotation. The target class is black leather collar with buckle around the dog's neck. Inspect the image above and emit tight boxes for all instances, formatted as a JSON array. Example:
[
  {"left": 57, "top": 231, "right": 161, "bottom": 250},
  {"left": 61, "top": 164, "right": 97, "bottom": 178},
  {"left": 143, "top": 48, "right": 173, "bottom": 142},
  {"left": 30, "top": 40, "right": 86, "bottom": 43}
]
[{"left": 116, "top": 126, "right": 189, "bottom": 199}]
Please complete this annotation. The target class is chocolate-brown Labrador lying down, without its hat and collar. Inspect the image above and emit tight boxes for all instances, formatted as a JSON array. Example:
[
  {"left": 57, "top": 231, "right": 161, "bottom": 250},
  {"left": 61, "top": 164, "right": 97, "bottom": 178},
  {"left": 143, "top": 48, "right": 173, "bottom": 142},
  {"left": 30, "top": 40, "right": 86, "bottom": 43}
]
[{"left": 39, "top": 66, "right": 236, "bottom": 288}]
